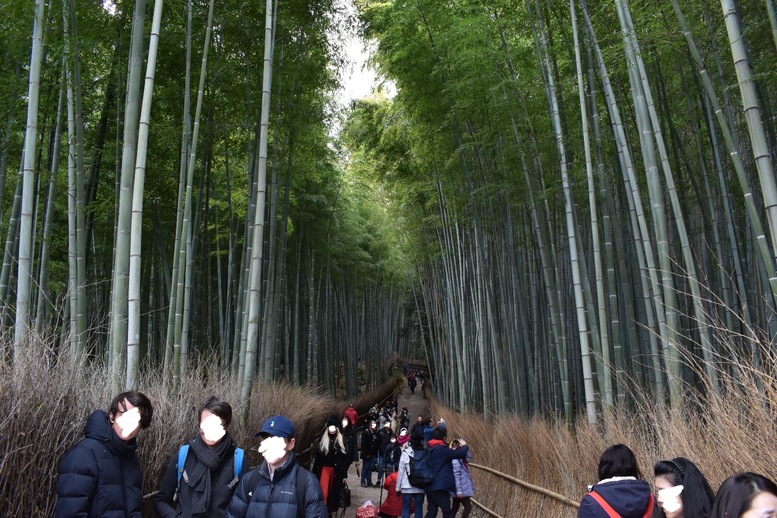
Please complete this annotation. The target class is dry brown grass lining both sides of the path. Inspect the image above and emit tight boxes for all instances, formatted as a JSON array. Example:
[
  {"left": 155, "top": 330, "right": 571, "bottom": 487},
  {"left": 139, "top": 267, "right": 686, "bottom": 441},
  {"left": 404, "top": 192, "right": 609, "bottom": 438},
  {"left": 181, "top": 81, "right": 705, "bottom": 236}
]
[{"left": 0, "top": 340, "right": 777, "bottom": 517}]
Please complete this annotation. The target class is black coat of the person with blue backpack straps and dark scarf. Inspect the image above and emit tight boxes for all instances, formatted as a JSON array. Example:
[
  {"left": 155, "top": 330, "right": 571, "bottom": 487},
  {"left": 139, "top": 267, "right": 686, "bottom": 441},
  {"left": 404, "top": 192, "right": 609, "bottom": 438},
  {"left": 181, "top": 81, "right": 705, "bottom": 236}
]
[{"left": 154, "top": 439, "right": 239, "bottom": 518}]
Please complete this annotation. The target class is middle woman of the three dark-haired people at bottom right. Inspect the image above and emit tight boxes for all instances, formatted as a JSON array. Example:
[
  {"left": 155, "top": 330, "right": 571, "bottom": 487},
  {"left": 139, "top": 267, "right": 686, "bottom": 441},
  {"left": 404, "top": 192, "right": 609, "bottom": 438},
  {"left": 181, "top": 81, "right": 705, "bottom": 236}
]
[{"left": 653, "top": 457, "right": 715, "bottom": 518}]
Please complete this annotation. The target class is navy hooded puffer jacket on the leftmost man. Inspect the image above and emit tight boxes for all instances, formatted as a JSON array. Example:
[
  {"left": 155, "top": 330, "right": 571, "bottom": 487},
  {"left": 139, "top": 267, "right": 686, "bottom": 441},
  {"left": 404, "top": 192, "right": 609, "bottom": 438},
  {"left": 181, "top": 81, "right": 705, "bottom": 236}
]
[{"left": 54, "top": 410, "right": 143, "bottom": 518}]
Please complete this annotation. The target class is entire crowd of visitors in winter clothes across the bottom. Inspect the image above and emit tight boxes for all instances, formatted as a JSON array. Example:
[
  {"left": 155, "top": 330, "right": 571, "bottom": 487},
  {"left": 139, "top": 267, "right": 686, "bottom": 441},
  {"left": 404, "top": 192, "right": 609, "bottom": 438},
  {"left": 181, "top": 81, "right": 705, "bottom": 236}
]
[{"left": 55, "top": 391, "right": 777, "bottom": 518}]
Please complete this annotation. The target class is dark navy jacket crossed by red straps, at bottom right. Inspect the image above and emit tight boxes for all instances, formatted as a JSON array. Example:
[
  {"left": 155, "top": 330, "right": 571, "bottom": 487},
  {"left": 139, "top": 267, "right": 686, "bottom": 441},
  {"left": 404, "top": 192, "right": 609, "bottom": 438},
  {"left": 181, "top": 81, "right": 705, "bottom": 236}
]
[{"left": 577, "top": 477, "right": 653, "bottom": 518}]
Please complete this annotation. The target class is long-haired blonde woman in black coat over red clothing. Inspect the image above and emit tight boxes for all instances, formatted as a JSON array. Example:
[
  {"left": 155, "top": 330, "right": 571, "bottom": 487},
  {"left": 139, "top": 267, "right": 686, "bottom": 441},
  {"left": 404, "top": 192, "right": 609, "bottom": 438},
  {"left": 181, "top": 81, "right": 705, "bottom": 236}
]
[{"left": 313, "top": 415, "right": 351, "bottom": 516}]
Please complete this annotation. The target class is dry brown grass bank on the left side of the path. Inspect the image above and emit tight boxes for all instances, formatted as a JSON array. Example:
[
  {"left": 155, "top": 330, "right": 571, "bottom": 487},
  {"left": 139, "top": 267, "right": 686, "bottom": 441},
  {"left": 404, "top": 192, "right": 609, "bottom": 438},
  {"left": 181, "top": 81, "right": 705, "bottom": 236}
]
[{"left": 0, "top": 339, "right": 394, "bottom": 517}]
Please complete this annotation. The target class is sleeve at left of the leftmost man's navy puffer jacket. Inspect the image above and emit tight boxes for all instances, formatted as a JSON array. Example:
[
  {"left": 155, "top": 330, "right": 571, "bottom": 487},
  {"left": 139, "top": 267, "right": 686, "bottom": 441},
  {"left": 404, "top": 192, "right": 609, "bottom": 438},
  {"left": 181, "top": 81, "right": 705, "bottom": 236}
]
[{"left": 54, "top": 446, "right": 99, "bottom": 518}]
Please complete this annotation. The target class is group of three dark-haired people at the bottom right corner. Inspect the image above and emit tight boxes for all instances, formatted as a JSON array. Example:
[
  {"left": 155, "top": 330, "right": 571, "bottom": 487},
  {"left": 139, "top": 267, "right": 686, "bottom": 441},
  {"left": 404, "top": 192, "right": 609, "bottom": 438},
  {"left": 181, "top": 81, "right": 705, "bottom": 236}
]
[{"left": 577, "top": 444, "right": 777, "bottom": 518}]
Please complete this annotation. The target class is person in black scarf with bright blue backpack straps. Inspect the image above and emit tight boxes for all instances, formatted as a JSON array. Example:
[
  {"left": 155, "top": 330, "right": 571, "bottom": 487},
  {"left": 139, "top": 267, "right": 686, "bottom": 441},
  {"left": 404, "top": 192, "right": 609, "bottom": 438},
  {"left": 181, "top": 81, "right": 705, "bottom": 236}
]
[{"left": 154, "top": 397, "right": 243, "bottom": 518}]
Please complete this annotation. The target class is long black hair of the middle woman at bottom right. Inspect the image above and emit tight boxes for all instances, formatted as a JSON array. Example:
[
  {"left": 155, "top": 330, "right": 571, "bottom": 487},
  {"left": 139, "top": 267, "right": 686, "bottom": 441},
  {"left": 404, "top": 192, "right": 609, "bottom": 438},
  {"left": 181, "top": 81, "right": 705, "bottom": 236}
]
[{"left": 653, "top": 457, "right": 715, "bottom": 518}]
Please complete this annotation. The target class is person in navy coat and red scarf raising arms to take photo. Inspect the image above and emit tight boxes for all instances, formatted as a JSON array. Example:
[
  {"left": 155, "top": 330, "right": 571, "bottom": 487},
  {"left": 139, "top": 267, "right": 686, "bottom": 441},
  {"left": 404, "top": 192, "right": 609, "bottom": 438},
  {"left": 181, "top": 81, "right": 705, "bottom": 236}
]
[{"left": 425, "top": 426, "right": 469, "bottom": 518}]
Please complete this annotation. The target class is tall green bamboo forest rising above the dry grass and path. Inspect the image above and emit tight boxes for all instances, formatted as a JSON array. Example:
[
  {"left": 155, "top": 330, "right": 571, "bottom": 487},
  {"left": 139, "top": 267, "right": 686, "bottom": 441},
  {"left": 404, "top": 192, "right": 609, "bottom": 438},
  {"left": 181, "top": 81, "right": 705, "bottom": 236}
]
[{"left": 0, "top": 0, "right": 777, "bottom": 425}]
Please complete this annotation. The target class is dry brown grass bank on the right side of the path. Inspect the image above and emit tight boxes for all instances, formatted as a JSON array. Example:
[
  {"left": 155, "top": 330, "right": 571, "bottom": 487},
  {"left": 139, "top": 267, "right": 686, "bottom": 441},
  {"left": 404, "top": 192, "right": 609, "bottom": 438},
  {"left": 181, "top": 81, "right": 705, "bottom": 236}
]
[{"left": 431, "top": 354, "right": 777, "bottom": 517}]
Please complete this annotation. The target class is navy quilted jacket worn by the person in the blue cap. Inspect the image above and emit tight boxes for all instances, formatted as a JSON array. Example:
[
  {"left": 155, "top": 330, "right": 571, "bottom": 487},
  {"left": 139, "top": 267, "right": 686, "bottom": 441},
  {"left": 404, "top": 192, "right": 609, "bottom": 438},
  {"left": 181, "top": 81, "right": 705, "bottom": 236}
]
[{"left": 227, "top": 452, "right": 328, "bottom": 518}]
